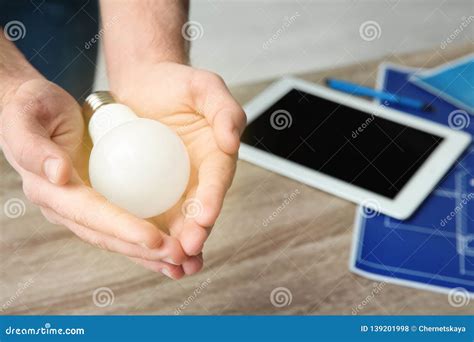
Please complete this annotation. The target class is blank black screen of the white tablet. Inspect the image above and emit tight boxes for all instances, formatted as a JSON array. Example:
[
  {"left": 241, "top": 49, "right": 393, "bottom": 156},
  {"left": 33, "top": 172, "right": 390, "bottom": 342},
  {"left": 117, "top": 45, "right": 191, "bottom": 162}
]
[{"left": 242, "top": 89, "right": 443, "bottom": 198}]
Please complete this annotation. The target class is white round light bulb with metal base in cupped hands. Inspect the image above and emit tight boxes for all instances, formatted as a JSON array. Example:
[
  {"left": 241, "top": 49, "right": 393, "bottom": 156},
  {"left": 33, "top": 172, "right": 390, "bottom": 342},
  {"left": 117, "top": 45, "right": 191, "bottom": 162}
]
[{"left": 84, "top": 91, "right": 190, "bottom": 218}]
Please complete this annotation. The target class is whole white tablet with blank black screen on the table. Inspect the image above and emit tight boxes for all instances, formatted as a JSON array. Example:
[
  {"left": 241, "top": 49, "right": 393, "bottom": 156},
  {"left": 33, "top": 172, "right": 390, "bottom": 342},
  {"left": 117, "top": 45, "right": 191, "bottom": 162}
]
[{"left": 239, "top": 78, "right": 471, "bottom": 219}]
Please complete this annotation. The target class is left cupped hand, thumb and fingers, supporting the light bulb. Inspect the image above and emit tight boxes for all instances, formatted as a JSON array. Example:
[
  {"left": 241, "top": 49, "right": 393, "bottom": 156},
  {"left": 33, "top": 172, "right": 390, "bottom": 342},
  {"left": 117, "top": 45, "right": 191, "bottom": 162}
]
[{"left": 0, "top": 76, "right": 190, "bottom": 279}]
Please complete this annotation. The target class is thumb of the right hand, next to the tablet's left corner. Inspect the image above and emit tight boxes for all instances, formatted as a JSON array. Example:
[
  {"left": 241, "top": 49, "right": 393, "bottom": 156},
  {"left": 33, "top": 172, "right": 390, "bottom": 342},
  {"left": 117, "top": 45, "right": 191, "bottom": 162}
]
[{"left": 191, "top": 70, "right": 246, "bottom": 154}]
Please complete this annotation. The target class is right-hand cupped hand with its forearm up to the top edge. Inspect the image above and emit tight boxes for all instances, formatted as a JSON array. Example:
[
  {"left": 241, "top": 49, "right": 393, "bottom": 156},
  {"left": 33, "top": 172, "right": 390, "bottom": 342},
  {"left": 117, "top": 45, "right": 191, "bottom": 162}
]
[{"left": 100, "top": 0, "right": 245, "bottom": 274}]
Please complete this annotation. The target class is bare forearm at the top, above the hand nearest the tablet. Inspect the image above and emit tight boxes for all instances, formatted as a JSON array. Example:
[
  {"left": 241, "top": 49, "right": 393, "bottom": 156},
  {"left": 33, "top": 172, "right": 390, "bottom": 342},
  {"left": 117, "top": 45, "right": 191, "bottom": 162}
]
[{"left": 101, "top": 0, "right": 189, "bottom": 89}]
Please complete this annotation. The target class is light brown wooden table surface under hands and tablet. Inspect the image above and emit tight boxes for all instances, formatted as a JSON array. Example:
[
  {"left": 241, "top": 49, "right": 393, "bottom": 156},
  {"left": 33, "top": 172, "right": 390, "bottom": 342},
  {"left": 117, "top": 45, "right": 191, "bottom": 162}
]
[{"left": 0, "top": 46, "right": 474, "bottom": 315}]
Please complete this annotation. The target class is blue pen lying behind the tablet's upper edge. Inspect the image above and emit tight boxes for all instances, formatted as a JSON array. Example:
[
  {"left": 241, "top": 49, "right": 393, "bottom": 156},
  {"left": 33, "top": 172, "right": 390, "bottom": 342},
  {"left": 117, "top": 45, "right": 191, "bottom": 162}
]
[{"left": 326, "top": 78, "right": 432, "bottom": 111}]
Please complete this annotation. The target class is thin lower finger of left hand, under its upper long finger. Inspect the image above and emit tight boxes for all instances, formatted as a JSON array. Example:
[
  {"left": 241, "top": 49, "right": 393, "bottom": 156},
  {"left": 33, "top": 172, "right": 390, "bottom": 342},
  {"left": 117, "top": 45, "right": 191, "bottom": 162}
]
[{"left": 40, "top": 207, "right": 184, "bottom": 266}]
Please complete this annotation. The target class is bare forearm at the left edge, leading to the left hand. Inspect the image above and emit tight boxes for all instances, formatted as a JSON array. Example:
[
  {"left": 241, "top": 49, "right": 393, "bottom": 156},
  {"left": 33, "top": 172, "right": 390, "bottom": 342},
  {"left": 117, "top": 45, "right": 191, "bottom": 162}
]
[{"left": 0, "top": 34, "right": 42, "bottom": 110}]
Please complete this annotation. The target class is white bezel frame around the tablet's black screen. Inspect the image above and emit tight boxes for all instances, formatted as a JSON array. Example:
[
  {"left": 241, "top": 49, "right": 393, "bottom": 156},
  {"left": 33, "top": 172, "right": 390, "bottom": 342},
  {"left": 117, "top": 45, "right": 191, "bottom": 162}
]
[{"left": 239, "top": 77, "right": 471, "bottom": 219}]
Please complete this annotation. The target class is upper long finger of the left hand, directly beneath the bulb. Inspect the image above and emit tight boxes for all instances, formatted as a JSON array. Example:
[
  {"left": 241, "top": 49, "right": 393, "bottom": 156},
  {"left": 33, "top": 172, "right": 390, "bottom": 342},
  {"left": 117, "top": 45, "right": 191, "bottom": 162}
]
[{"left": 23, "top": 177, "right": 186, "bottom": 264}]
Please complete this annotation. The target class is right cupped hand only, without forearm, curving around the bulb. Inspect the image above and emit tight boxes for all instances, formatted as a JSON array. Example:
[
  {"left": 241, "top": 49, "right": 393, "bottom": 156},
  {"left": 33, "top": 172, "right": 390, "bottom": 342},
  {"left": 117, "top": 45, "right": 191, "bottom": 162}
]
[{"left": 111, "top": 63, "right": 246, "bottom": 274}]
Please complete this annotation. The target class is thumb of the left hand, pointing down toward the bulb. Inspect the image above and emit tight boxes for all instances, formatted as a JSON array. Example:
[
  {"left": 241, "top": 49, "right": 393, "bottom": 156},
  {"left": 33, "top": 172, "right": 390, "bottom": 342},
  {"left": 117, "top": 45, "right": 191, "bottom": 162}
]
[{"left": 2, "top": 103, "right": 72, "bottom": 184}]
